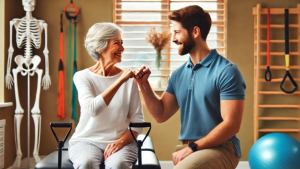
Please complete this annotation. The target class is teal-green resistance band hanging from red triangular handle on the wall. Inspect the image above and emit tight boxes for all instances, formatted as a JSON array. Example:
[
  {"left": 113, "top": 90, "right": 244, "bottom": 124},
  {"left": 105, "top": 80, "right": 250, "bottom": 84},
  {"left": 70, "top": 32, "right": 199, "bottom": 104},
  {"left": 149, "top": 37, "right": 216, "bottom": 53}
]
[{"left": 64, "top": 0, "right": 79, "bottom": 124}]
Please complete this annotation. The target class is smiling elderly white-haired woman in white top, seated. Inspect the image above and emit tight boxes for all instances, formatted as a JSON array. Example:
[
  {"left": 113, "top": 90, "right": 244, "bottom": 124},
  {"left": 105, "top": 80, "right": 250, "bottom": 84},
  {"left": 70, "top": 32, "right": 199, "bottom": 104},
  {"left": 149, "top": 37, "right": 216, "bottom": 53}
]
[{"left": 69, "top": 23, "right": 144, "bottom": 169}]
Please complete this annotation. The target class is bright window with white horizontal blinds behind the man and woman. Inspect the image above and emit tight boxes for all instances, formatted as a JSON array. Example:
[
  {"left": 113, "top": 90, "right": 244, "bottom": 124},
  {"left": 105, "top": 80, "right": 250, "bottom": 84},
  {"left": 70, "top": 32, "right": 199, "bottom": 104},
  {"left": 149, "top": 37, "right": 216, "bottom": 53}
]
[{"left": 113, "top": 0, "right": 227, "bottom": 89}]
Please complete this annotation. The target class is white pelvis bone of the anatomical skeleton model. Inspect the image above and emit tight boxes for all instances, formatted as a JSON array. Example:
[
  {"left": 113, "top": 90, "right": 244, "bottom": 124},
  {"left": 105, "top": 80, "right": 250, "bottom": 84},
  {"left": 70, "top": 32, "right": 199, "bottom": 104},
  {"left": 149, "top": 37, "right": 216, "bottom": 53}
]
[{"left": 15, "top": 55, "right": 41, "bottom": 76}]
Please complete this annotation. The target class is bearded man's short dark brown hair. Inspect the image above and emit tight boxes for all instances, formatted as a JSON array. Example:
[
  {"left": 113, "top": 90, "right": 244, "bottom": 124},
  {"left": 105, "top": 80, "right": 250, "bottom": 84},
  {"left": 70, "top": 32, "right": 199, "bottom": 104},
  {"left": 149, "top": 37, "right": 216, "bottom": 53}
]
[{"left": 168, "top": 5, "right": 211, "bottom": 40}]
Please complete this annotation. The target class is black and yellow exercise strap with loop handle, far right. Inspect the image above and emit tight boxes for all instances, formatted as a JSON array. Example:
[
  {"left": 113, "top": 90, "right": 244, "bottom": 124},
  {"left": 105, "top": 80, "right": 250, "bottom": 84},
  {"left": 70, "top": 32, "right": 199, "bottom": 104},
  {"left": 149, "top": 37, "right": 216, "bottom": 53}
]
[{"left": 280, "top": 9, "right": 298, "bottom": 93}]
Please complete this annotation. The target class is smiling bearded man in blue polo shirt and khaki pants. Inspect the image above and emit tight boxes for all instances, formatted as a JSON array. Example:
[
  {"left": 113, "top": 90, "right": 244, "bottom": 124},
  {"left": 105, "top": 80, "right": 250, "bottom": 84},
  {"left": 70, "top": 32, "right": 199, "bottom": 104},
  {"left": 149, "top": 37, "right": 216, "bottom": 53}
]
[{"left": 134, "top": 5, "right": 246, "bottom": 169}]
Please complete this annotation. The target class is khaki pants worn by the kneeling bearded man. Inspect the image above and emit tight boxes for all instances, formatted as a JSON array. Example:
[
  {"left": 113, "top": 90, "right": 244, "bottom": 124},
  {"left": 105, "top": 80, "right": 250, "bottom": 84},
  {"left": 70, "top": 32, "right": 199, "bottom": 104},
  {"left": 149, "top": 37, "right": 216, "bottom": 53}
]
[{"left": 174, "top": 141, "right": 240, "bottom": 169}]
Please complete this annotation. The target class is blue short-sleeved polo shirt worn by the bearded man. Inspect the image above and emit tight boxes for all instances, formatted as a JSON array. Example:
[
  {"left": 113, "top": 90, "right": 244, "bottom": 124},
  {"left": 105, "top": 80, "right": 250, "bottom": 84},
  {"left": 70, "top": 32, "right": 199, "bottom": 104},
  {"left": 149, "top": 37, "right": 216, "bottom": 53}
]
[{"left": 166, "top": 49, "right": 246, "bottom": 157}]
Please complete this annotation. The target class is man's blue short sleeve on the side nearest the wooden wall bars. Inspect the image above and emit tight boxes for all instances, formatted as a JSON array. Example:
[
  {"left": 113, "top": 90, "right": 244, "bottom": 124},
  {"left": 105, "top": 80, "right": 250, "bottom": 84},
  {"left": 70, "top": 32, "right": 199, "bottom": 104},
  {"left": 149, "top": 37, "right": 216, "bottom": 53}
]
[{"left": 219, "top": 64, "right": 246, "bottom": 100}]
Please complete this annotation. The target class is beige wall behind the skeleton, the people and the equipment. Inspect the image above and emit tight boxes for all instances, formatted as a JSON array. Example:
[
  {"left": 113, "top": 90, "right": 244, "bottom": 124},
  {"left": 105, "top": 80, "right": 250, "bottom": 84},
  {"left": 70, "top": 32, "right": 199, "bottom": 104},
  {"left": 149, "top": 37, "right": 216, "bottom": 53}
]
[{"left": 0, "top": 0, "right": 298, "bottom": 168}]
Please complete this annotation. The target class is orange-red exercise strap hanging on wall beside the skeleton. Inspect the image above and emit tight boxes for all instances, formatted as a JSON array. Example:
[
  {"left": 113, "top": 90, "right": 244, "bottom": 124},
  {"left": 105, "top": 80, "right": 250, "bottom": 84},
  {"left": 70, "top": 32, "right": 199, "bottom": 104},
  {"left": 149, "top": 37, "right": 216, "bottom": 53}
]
[{"left": 57, "top": 13, "right": 65, "bottom": 119}]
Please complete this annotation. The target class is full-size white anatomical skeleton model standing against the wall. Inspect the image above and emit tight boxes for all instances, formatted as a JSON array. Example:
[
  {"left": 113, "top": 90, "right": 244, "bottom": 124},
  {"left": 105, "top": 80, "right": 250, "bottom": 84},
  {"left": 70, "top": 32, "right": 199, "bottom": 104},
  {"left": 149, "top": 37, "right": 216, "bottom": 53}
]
[{"left": 5, "top": 0, "right": 51, "bottom": 168}]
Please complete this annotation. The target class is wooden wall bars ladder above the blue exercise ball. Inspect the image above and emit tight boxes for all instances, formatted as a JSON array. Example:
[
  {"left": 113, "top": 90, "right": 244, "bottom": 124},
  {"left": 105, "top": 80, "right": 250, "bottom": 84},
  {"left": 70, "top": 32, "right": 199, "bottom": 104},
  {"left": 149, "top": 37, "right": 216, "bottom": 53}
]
[{"left": 252, "top": 4, "right": 300, "bottom": 142}]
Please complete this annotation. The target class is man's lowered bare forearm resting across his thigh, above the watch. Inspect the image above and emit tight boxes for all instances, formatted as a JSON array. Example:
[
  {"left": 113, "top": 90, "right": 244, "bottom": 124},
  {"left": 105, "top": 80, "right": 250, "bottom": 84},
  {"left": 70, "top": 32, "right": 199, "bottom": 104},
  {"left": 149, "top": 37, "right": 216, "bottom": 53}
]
[{"left": 195, "top": 121, "right": 239, "bottom": 150}]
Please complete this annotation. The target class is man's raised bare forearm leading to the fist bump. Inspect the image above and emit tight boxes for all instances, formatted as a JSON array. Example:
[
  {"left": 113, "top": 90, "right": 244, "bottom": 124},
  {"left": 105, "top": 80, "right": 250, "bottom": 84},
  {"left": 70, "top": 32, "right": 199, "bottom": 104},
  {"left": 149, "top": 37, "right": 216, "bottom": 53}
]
[{"left": 140, "top": 80, "right": 164, "bottom": 122}]
